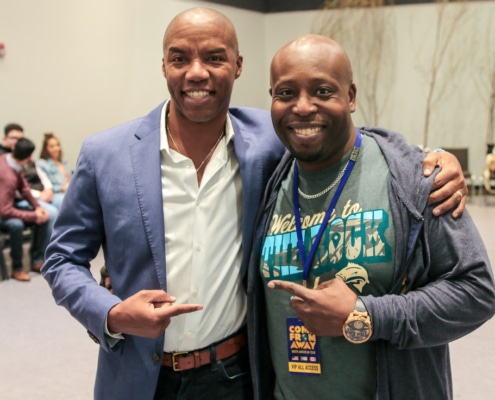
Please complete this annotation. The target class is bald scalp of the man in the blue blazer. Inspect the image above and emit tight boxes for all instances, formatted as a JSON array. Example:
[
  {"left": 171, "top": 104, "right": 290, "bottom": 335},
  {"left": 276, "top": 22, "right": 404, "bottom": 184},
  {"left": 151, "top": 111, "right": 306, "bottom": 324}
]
[{"left": 163, "top": 7, "right": 239, "bottom": 56}]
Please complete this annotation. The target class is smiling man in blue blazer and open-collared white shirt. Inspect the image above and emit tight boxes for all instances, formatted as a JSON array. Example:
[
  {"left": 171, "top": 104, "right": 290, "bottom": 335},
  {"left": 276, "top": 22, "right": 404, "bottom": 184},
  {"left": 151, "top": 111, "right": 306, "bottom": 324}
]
[{"left": 42, "top": 8, "right": 468, "bottom": 400}]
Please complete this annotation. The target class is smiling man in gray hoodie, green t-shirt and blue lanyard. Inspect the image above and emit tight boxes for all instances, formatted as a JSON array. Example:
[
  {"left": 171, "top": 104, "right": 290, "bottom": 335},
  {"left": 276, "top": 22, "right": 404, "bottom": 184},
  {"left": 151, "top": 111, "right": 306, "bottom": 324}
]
[{"left": 247, "top": 35, "right": 495, "bottom": 400}]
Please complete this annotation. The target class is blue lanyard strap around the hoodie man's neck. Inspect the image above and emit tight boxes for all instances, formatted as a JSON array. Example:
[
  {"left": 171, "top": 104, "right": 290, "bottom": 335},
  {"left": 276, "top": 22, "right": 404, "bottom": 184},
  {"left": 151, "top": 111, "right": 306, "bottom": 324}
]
[{"left": 292, "top": 129, "right": 362, "bottom": 287}]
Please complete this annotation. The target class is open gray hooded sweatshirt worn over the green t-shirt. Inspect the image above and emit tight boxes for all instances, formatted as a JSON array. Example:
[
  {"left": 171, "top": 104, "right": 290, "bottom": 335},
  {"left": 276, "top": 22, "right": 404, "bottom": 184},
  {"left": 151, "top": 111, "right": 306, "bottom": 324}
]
[{"left": 248, "top": 127, "right": 495, "bottom": 400}]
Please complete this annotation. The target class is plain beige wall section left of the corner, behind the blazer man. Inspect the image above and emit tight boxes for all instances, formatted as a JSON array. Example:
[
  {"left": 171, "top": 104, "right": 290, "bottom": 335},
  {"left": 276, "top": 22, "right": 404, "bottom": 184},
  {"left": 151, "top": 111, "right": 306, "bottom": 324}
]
[{"left": 0, "top": 0, "right": 267, "bottom": 166}]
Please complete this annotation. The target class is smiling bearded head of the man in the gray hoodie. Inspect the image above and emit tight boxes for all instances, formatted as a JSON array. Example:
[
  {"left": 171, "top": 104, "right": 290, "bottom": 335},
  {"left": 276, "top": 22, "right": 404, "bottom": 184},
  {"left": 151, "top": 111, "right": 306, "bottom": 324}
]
[{"left": 270, "top": 35, "right": 356, "bottom": 170}]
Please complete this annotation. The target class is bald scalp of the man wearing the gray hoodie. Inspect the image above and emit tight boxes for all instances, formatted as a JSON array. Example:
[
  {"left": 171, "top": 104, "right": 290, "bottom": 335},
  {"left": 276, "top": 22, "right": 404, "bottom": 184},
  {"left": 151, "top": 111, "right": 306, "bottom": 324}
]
[{"left": 270, "top": 34, "right": 353, "bottom": 86}]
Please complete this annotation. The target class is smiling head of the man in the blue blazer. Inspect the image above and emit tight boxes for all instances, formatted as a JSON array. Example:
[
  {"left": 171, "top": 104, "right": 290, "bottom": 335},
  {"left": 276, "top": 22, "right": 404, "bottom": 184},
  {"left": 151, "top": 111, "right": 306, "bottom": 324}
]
[{"left": 162, "top": 9, "right": 242, "bottom": 122}]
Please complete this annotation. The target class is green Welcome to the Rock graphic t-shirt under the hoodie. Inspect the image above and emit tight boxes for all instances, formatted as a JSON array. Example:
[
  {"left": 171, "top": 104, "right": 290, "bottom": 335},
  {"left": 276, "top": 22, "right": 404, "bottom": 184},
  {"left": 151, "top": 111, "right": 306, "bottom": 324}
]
[{"left": 260, "top": 135, "right": 395, "bottom": 400}]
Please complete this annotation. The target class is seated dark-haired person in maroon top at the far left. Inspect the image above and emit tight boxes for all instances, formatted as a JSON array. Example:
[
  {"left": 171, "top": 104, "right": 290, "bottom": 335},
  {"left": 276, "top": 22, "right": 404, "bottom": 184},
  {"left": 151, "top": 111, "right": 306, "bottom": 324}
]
[{"left": 0, "top": 138, "right": 50, "bottom": 281}]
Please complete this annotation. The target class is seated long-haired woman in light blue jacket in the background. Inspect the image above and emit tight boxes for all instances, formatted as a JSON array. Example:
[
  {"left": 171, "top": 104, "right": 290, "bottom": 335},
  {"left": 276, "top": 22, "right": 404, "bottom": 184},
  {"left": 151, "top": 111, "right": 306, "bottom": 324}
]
[{"left": 36, "top": 133, "right": 71, "bottom": 209}]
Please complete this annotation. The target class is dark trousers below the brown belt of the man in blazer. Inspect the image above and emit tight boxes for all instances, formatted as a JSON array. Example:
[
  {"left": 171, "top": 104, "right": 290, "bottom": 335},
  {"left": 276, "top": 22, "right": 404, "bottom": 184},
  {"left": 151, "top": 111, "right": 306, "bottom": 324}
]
[{"left": 154, "top": 346, "right": 253, "bottom": 400}]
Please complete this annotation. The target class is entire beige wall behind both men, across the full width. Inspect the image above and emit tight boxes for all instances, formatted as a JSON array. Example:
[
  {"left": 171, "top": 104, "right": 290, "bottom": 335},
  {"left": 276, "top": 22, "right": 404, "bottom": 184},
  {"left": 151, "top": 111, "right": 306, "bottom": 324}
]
[{"left": 0, "top": 0, "right": 495, "bottom": 174}]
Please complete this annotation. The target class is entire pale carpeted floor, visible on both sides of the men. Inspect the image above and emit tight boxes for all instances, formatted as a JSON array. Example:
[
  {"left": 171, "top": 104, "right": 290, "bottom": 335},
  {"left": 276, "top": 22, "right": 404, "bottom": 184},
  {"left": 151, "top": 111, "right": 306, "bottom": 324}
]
[{"left": 0, "top": 197, "right": 495, "bottom": 400}]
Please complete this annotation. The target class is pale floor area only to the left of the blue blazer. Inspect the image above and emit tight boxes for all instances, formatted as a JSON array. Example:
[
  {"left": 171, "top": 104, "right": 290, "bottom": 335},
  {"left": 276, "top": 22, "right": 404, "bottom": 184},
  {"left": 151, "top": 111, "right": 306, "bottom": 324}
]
[{"left": 0, "top": 255, "right": 99, "bottom": 400}]
